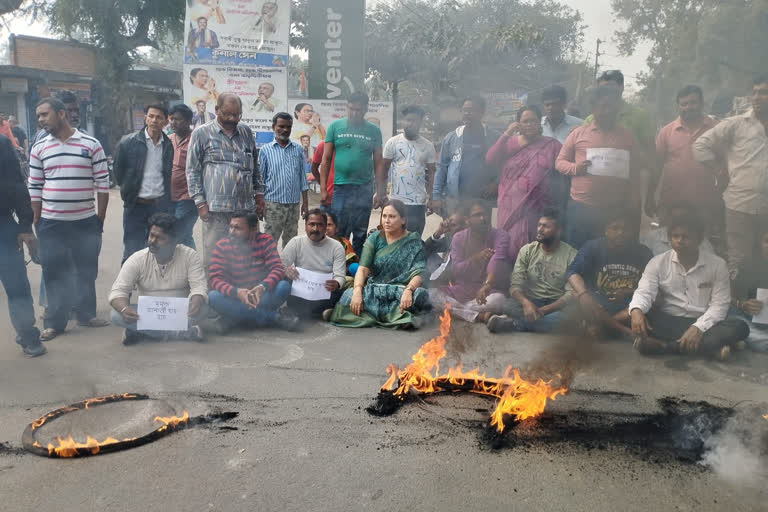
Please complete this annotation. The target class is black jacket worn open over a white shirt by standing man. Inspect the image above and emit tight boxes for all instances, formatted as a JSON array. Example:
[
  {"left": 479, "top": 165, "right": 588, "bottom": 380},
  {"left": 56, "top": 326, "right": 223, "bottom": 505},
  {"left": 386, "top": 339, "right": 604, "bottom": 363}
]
[{"left": 112, "top": 128, "right": 173, "bottom": 206}]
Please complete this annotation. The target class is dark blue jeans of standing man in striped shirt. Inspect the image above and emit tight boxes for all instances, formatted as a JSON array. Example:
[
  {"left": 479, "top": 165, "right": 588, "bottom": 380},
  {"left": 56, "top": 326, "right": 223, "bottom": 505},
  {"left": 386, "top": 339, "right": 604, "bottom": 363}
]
[{"left": 35, "top": 215, "right": 102, "bottom": 331}]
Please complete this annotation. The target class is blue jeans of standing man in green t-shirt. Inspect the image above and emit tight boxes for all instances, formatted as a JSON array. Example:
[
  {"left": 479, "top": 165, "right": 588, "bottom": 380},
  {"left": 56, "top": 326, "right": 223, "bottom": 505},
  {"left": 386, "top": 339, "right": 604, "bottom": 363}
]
[{"left": 331, "top": 181, "right": 373, "bottom": 255}]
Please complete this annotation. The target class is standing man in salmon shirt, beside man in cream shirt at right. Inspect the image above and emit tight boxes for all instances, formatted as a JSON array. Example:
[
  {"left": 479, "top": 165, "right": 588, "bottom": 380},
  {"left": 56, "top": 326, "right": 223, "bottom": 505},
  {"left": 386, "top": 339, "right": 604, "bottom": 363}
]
[{"left": 645, "top": 85, "right": 724, "bottom": 235}]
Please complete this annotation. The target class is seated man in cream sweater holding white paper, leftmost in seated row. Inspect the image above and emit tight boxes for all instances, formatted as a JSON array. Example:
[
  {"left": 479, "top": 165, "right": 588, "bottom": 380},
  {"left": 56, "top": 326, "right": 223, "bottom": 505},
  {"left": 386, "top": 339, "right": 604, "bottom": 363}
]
[{"left": 109, "top": 213, "right": 208, "bottom": 345}]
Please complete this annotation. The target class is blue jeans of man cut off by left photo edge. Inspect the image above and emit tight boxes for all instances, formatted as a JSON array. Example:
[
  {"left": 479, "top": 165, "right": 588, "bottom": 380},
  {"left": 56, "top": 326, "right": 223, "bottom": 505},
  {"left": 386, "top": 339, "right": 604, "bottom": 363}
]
[{"left": 0, "top": 216, "right": 40, "bottom": 346}]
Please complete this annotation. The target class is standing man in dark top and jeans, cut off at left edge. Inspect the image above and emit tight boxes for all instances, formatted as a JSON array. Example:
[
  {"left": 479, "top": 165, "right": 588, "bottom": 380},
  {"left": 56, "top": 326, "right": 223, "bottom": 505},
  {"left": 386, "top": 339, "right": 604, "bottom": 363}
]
[{"left": 0, "top": 130, "right": 46, "bottom": 357}]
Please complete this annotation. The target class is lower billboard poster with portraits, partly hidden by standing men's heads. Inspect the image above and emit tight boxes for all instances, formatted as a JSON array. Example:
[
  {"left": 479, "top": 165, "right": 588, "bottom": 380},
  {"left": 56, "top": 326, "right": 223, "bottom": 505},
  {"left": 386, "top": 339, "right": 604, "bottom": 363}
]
[{"left": 184, "top": 64, "right": 288, "bottom": 143}]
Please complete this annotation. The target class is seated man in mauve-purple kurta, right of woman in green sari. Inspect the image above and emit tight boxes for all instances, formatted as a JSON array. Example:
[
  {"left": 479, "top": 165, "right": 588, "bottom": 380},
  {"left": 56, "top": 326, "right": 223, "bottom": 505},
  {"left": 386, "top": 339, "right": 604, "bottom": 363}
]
[{"left": 429, "top": 200, "right": 509, "bottom": 323}]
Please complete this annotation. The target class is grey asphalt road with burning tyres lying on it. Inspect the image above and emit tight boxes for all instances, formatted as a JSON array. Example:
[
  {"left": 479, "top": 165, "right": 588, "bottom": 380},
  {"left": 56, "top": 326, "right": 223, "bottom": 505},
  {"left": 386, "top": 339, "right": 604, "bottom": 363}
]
[{"left": 0, "top": 192, "right": 768, "bottom": 512}]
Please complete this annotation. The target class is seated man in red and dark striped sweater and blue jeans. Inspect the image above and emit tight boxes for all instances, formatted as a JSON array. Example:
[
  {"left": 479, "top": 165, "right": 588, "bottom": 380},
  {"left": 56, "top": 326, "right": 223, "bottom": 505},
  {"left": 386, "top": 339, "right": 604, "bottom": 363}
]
[{"left": 208, "top": 211, "right": 299, "bottom": 334}]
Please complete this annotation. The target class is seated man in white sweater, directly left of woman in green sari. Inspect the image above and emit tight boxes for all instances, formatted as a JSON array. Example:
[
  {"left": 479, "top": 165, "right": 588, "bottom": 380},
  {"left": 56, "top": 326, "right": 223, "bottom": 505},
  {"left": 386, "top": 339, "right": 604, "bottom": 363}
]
[{"left": 282, "top": 208, "right": 347, "bottom": 316}]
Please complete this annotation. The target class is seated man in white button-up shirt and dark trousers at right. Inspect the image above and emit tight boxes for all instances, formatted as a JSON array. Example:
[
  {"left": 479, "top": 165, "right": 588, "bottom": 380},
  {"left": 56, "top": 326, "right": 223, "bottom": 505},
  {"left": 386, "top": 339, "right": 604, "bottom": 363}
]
[{"left": 629, "top": 215, "right": 749, "bottom": 359}]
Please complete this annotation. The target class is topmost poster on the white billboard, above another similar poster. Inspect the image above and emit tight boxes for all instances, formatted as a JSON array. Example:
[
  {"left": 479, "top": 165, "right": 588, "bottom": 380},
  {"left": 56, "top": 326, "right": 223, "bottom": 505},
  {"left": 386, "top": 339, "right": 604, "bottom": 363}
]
[{"left": 184, "top": 0, "right": 291, "bottom": 67}]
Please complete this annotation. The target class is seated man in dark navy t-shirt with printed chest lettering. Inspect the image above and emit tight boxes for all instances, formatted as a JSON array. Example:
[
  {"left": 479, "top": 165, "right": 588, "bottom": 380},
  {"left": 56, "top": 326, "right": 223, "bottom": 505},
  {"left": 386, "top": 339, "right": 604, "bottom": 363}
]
[{"left": 568, "top": 212, "right": 652, "bottom": 336}]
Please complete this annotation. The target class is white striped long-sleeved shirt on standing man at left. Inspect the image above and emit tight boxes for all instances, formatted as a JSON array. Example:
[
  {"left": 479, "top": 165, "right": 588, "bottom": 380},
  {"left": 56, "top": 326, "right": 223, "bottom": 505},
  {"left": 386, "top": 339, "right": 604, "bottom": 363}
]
[{"left": 29, "top": 130, "right": 109, "bottom": 221}]
